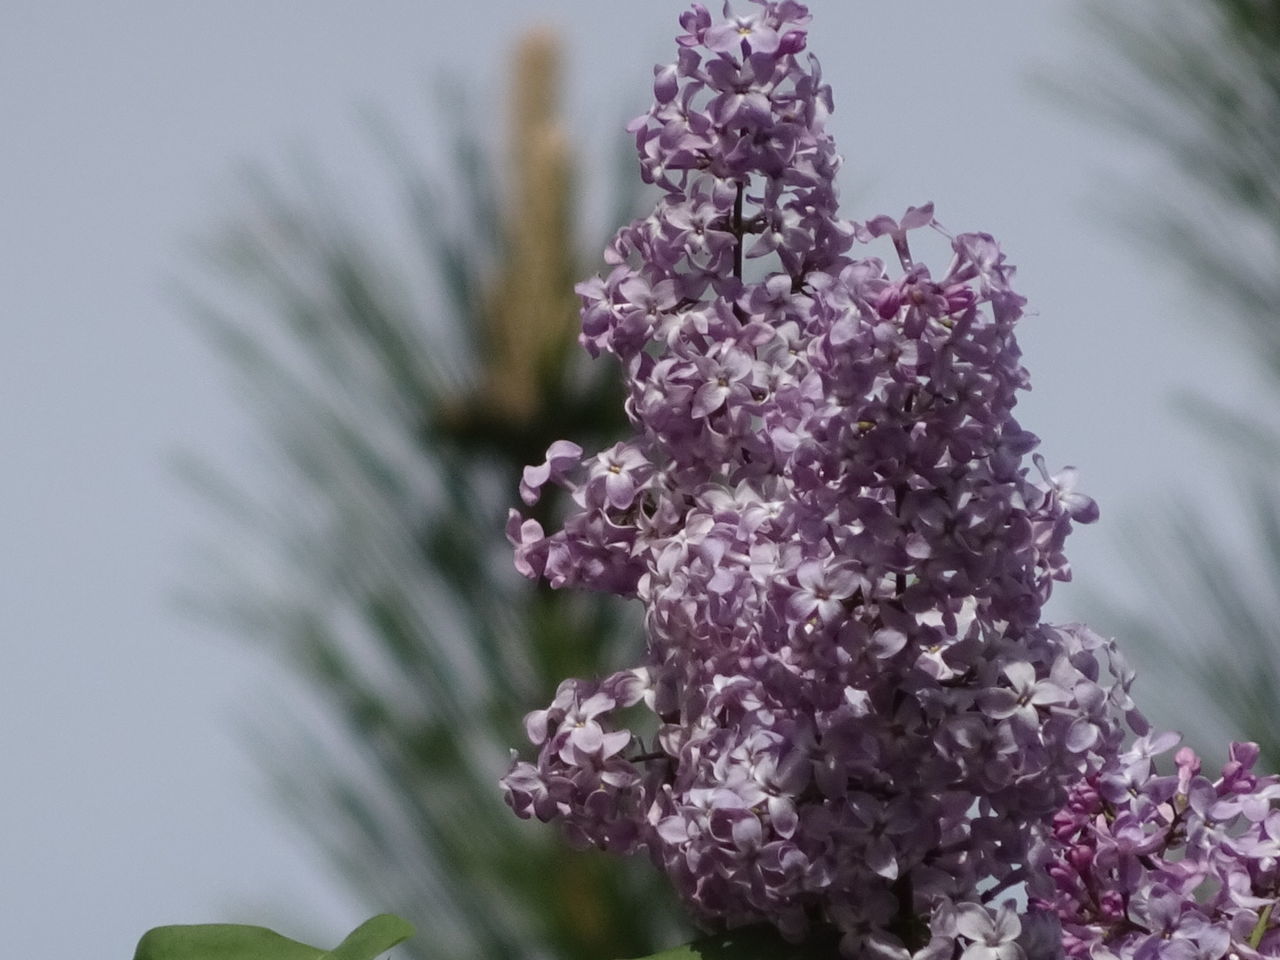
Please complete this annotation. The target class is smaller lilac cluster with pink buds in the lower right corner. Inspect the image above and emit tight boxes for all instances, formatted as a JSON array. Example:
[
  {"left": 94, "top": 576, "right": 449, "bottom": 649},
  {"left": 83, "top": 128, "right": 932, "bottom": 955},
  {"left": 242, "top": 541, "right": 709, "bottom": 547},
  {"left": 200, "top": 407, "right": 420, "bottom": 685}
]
[{"left": 1033, "top": 733, "right": 1280, "bottom": 960}]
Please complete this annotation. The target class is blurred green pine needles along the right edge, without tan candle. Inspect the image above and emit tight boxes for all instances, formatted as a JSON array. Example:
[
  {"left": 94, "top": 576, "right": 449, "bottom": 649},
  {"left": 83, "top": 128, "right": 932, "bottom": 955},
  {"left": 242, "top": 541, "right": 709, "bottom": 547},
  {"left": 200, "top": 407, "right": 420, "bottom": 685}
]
[{"left": 1073, "top": 0, "right": 1280, "bottom": 771}]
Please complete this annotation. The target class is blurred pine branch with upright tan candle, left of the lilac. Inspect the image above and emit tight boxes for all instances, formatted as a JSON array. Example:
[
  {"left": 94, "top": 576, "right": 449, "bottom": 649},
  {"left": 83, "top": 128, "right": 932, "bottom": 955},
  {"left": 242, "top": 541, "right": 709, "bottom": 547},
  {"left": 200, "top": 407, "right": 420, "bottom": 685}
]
[{"left": 180, "top": 31, "right": 687, "bottom": 960}]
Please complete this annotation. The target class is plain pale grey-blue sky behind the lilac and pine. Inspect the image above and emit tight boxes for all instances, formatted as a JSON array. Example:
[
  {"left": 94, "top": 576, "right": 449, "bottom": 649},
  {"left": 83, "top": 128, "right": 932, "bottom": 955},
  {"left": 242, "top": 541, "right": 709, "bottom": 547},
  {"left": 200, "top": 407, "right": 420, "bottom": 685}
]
[{"left": 0, "top": 0, "right": 1244, "bottom": 960}]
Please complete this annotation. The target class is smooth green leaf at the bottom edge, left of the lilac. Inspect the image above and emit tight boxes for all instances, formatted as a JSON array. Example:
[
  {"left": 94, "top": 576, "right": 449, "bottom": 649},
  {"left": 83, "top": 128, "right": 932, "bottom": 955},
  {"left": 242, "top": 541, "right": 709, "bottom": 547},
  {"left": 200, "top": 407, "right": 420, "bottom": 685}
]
[{"left": 133, "top": 914, "right": 413, "bottom": 960}]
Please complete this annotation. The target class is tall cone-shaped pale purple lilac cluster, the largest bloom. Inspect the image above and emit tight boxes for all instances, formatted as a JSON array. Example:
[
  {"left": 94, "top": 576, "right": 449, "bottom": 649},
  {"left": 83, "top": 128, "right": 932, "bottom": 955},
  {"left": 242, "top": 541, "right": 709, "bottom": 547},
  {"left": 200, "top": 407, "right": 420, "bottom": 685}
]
[{"left": 504, "top": 0, "right": 1133, "bottom": 960}]
